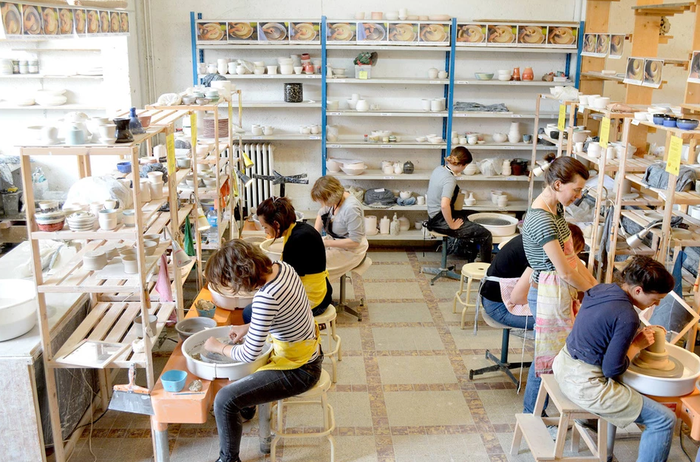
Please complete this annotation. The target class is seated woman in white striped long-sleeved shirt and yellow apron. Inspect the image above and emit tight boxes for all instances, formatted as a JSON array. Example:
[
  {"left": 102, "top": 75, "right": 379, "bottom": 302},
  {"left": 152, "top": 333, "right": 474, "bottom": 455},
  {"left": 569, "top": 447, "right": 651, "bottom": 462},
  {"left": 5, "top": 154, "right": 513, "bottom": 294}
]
[{"left": 204, "top": 239, "right": 323, "bottom": 462}]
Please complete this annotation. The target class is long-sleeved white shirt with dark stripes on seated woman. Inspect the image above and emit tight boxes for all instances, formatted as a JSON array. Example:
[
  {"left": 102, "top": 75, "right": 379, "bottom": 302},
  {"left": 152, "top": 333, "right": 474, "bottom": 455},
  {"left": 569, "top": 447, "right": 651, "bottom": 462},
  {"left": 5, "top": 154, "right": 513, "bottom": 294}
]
[{"left": 231, "top": 262, "right": 318, "bottom": 363}]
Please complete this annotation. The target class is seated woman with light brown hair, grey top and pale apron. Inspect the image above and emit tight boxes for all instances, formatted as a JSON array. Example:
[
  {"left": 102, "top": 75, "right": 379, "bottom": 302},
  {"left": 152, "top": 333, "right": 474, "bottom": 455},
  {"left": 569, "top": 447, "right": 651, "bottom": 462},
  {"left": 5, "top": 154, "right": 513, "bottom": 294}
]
[{"left": 311, "top": 175, "right": 369, "bottom": 282}]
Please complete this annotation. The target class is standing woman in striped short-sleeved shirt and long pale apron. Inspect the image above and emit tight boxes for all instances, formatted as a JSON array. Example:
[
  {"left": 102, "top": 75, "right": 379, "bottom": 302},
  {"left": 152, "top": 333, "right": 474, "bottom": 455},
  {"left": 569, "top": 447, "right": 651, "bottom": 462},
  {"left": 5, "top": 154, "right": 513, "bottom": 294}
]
[{"left": 522, "top": 156, "right": 594, "bottom": 413}]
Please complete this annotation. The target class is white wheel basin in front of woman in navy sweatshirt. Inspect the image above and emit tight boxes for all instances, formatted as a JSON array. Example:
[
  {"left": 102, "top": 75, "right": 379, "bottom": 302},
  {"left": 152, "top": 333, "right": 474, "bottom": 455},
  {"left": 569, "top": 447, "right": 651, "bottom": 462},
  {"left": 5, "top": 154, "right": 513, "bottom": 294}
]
[{"left": 622, "top": 343, "right": 700, "bottom": 396}]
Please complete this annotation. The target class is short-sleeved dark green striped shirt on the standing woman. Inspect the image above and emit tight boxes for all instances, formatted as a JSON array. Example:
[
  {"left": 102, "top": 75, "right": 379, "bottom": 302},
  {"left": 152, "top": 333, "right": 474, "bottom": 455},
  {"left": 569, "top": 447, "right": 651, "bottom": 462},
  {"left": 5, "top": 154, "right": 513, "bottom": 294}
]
[{"left": 522, "top": 203, "right": 571, "bottom": 282}]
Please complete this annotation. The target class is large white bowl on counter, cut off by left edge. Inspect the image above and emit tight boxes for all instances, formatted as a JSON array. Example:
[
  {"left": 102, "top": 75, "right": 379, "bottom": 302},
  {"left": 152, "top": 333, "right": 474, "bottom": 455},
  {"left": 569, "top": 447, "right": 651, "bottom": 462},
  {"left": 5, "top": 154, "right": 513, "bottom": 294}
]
[{"left": 0, "top": 279, "right": 39, "bottom": 342}]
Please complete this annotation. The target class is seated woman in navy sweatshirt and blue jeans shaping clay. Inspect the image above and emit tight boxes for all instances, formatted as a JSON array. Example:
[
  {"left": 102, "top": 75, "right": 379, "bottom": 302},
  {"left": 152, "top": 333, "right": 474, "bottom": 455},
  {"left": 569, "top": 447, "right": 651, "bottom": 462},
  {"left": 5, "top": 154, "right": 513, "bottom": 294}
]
[{"left": 552, "top": 256, "right": 676, "bottom": 462}]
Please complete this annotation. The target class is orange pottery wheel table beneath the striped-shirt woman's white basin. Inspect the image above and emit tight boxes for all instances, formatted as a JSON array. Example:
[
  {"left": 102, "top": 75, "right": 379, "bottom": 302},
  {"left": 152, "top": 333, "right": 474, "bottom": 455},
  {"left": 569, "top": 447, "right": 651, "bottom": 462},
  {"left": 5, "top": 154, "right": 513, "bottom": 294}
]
[{"left": 151, "top": 289, "right": 271, "bottom": 462}]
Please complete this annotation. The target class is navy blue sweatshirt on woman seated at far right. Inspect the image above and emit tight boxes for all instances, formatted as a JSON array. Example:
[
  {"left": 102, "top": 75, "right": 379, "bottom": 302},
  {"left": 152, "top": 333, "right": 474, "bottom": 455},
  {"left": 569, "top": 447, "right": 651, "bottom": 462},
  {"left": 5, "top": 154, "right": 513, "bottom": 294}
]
[{"left": 566, "top": 284, "right": 640, "bottom": 378}]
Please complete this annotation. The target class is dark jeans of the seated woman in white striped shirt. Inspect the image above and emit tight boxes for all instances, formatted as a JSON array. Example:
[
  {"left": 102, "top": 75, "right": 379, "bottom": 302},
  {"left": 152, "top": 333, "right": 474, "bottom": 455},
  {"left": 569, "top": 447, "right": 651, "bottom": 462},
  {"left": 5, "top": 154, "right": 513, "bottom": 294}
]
[{"left": 214, "top": 354, "right": 323, "bottom": 462}]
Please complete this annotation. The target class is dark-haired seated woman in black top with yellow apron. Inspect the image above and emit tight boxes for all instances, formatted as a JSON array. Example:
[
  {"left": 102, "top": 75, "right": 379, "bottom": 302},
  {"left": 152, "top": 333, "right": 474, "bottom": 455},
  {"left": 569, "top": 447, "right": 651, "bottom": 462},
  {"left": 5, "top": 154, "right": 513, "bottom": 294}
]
[{"left": 243, "top": 197, "right": 333, "bottom": 324}]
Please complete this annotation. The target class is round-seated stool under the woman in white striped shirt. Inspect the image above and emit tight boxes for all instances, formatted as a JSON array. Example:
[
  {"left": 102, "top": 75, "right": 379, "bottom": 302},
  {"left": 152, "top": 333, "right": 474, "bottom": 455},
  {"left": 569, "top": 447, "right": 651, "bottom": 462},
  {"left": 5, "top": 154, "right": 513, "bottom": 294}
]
[{"left": 270, "top": 370, "right": 335, "bottom": 462}]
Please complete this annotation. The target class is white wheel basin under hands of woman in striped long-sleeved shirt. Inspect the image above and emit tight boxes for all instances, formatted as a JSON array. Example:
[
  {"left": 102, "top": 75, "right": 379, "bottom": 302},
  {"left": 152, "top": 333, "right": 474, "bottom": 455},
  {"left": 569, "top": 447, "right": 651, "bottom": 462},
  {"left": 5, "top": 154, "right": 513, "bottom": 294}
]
[{"left": 182, "top": 326, "right": 272, "bottom": 380}]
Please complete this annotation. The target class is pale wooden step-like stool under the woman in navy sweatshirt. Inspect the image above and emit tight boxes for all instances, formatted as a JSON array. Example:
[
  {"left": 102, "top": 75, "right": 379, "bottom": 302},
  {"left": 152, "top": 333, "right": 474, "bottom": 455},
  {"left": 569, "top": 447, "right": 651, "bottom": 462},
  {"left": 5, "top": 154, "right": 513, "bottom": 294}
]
[{"left": 510, "top": 374, "right": 608, "bottom": 462}]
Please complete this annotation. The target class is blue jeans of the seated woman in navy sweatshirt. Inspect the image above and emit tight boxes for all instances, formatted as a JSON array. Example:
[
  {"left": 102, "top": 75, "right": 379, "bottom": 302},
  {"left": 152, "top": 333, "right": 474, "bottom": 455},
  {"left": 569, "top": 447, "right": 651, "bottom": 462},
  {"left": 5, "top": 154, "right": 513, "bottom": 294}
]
[{"left": 634, "top": 395, "right": 676, "bottom": 462}]
